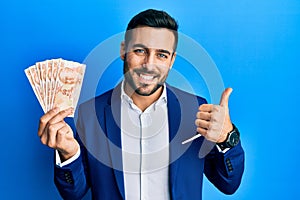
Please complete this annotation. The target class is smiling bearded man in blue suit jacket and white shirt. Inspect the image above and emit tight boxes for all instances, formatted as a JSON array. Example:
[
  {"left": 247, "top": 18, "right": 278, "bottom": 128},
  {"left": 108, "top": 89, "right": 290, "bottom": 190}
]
[{"left": 38, "top": 9, "right": 244, "bottom": 200}]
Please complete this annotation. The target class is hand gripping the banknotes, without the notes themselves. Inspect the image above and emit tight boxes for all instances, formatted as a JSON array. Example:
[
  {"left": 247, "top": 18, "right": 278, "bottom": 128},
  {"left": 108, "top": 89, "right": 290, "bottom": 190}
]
[{"left": 38, "top": 108, "right": 79, "bottom": 162}]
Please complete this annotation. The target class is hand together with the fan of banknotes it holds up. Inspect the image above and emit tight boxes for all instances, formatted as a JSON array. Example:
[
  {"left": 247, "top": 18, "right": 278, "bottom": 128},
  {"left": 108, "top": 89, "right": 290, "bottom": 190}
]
[{"left": 24, "top": 58, "right": 86, "bottom": 161}]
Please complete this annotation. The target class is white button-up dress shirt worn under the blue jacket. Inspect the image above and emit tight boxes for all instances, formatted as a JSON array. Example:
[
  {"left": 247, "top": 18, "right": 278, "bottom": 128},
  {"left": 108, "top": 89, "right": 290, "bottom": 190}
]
[{"left": 121, "top": 81, "right": 170, "bottom": 200}]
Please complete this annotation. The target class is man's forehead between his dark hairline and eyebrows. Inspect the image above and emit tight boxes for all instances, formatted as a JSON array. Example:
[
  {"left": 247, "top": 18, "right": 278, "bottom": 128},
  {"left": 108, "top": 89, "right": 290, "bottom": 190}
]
[{"left": 128, "top": 27, "right": 175, "bottom": 52}]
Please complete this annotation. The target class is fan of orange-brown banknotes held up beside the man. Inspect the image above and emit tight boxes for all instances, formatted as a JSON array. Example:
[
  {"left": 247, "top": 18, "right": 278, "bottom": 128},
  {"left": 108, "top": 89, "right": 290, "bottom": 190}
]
[{"left": 25, "top": 58, "right": 86, "bottom": 117}]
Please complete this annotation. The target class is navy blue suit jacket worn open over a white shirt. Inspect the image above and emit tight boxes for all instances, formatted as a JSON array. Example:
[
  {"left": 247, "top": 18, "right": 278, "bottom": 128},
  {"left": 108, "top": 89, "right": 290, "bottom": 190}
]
[{"left": 55, "top": 85, "right": 244, "bottom": 200}]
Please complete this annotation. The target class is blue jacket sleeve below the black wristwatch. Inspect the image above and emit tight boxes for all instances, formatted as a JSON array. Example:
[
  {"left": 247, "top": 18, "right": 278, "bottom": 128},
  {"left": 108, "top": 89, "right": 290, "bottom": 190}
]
[{"left": 204, "top": 142, "right": 245, "bottom": 194}]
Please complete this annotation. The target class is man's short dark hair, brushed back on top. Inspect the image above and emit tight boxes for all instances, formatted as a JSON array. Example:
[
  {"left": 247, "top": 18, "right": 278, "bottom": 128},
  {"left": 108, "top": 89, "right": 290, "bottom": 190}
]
[{"left": 125, "top": 9, "right": 178, "bottom": 51}]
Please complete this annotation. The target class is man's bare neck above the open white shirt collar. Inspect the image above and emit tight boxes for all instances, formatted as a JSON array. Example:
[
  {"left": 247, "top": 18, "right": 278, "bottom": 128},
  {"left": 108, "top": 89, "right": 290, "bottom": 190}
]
[{"left": 124, "top": 83, "right": 163, "bottom": 112}]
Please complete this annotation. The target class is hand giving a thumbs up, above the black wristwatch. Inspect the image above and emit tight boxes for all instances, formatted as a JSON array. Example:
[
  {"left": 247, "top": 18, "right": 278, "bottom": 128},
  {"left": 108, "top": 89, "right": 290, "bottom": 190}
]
[{"left": 195, "top": 88, "right": 233, "bottom": 143}]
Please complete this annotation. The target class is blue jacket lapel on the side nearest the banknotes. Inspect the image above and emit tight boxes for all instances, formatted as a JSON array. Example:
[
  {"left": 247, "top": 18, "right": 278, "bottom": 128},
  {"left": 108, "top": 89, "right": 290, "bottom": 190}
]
[{"left": 105, "top": 85, "right": 125, "bottom": 198}]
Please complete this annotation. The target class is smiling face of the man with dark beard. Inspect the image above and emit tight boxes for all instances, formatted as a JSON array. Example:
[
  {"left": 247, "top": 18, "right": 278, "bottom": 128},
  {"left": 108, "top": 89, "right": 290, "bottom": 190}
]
[{"left": 121, "top": 27, "right": 176, "bottom": 96}]
